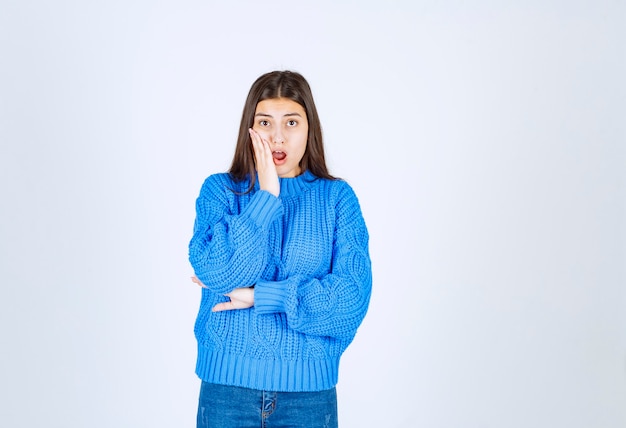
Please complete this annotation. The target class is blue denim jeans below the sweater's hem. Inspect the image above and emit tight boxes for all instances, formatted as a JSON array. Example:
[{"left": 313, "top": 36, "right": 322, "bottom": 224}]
[{"left": 197, "top": 381, "right": 338, "bottom": 428}]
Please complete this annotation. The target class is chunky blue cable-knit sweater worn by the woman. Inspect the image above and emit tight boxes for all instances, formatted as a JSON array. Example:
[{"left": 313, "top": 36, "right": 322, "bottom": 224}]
[{"left": 189, "top": 172, "right": 372, "bottom": 391}]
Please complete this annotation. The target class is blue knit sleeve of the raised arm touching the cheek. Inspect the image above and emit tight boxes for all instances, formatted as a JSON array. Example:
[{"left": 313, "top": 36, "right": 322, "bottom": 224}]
[{"left": 189, "top": 175, "right": 282, "bottom": 294}]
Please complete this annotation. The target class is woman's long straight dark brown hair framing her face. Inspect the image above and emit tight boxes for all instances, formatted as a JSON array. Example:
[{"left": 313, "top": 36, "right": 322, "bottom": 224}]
[{"left": 228, "top": 71, "right": 335, "bottom": 191}]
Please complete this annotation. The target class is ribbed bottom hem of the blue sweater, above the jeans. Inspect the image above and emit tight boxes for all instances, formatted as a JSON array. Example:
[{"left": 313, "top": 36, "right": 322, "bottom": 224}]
[{"left": 196, "top": 345, "right": 339, "bottom": 392}]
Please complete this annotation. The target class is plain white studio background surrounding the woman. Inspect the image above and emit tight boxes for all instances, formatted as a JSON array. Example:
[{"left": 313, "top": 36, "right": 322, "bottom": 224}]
[{"left": 0, "top": 0, "right": 626, "bottom": 428}]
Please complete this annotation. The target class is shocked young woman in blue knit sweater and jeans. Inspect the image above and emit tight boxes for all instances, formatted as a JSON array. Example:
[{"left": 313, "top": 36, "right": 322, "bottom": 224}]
[{"left": 189, "top": 71, "right": 372, "bottom": 428}]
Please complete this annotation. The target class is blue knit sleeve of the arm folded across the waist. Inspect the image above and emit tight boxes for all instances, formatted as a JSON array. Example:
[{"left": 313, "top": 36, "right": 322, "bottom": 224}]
[{"left": 254, "top": 185, "right": 372, "bottom": 340}]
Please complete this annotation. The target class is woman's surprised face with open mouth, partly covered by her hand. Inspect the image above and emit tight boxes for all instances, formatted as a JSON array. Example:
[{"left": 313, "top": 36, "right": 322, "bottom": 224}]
[{"left": 252, "top": 98, "right": 309, "bottom": 178}]
